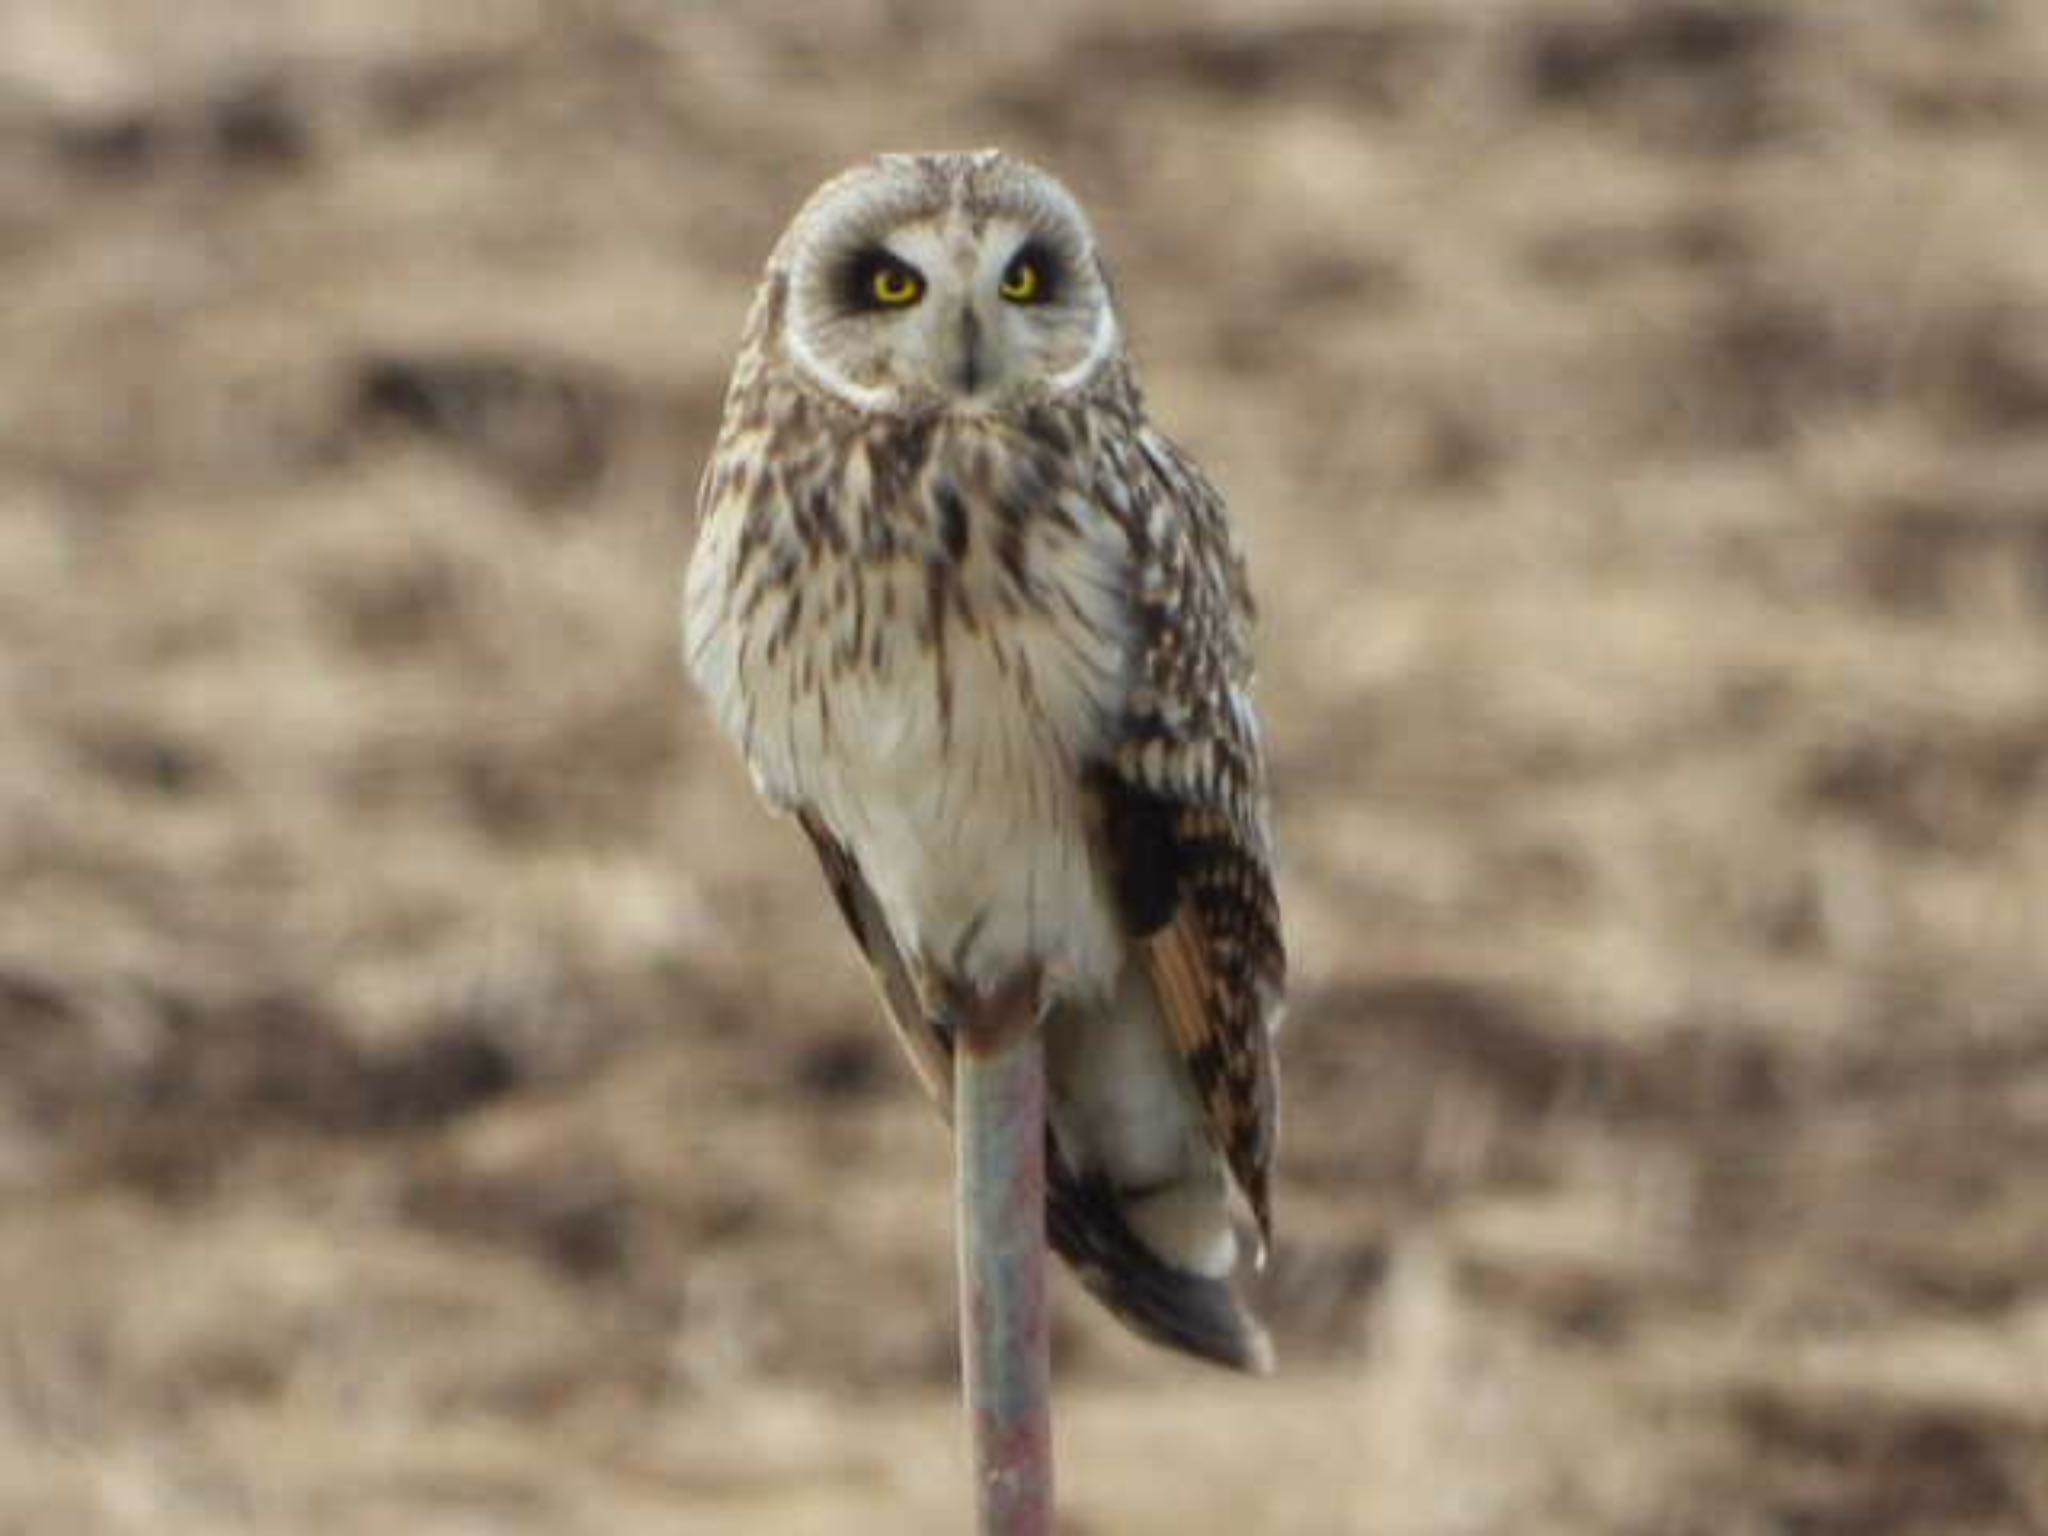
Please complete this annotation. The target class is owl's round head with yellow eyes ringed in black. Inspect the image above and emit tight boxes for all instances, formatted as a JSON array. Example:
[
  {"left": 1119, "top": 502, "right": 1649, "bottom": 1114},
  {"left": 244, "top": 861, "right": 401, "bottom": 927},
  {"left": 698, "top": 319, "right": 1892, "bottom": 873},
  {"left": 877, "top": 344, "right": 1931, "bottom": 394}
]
[{"left": 770, "top": 150, "right": 1122, "bottom": 412}]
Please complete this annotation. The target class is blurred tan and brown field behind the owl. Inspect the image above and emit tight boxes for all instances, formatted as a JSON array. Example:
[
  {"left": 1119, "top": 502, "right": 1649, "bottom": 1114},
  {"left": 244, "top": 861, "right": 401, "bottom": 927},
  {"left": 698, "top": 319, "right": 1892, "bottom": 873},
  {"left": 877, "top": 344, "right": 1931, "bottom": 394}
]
[{"left": 0, "top": 0, "right": 2048, "bottom": 1536}]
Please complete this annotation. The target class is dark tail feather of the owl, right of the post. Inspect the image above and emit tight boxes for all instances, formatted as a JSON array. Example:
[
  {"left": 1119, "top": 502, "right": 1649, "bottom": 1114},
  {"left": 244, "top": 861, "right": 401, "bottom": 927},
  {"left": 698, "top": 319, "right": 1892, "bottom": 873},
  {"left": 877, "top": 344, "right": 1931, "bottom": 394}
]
[{"left": 1044, "top": 1137, "right": 1274, "bottom": 1376}]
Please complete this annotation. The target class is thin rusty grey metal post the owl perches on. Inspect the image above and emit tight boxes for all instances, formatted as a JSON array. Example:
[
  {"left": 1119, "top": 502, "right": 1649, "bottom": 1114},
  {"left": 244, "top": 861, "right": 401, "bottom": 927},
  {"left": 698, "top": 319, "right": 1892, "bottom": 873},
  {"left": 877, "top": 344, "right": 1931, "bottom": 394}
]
[{"left": 952, "top": 975, "right": 1053, "bottom": 1536}]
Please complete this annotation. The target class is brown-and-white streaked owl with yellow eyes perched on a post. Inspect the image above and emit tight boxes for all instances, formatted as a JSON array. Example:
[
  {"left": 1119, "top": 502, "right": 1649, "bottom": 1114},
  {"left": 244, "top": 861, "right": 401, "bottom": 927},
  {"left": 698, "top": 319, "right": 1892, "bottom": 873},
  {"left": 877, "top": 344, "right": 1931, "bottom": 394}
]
[{"left": 684, "top": 150, "right": 1284, "bottom": 1370}]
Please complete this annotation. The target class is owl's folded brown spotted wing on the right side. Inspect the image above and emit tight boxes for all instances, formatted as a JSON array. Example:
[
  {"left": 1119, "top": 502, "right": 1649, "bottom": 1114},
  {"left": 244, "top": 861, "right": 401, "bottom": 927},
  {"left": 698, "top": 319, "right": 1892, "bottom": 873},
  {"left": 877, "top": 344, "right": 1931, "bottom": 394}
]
[{"left": 1090, "top": 428, "right": 1286, "bottom": 1239}]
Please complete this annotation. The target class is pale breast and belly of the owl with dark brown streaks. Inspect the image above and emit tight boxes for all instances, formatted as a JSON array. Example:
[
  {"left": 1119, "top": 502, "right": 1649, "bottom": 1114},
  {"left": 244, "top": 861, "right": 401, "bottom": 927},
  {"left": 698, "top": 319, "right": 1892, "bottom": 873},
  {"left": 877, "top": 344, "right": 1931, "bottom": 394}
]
[{"left": 686, "top": 411, "right": 1133, "bottom": 997}]
